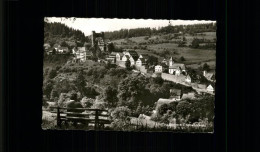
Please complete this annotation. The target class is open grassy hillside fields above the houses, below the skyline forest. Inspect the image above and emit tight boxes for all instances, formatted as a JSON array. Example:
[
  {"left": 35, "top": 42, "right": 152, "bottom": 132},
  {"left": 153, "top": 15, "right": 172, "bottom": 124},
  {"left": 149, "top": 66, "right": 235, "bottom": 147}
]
[{"left": 110, "top": 32, "right": 216, "bottom": 69}]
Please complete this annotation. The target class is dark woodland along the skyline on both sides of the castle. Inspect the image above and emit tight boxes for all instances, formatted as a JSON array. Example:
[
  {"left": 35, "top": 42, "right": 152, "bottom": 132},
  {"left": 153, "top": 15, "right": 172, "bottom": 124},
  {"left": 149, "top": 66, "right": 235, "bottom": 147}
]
[{"left": 44, "top": 22, "right": 217, "bottom": 46}]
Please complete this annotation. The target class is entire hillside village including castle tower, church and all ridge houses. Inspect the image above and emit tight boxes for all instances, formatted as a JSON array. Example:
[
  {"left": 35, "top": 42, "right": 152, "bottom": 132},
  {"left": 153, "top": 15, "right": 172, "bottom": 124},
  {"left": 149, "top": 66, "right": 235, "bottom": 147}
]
[{"left": 44, "top": 31, "right": 215, "bottom": 95}]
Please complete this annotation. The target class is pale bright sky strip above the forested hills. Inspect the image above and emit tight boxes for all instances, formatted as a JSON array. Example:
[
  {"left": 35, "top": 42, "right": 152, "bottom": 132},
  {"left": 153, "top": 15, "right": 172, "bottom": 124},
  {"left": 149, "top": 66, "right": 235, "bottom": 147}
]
[{"left": 47, "top": 17, "right": 216, "bottom": 36}]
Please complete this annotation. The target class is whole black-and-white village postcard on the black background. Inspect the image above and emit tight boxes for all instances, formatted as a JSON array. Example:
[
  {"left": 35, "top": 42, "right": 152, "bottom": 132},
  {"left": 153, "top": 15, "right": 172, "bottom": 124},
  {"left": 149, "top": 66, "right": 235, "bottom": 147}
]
[{"left": 41, "top": 17, "right": 216, "bottom": 133}]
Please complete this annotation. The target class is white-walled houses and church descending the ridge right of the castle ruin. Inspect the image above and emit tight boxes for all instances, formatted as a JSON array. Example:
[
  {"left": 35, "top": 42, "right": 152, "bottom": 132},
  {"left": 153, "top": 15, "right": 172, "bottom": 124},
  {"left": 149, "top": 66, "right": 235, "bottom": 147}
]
[{"left": 103, "top": 49, "right": 215, "bottom": 92}]
